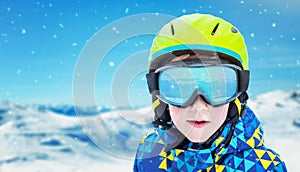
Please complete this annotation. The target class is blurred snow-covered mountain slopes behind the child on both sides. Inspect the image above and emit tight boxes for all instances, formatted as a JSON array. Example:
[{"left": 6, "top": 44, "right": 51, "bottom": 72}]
[{"left": 0, "top": 91, "right": 300, "bottom": 172}]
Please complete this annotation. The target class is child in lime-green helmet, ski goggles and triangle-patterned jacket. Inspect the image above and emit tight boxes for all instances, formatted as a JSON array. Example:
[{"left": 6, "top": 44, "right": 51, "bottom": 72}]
[{"left": 134, "top": 14, "right": 286, "bottom": 171}]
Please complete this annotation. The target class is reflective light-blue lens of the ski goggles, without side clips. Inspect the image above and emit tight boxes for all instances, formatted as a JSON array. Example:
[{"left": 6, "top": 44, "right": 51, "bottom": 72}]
[{"left": 158, "top": 66, "right": 238, "bottom": 107}]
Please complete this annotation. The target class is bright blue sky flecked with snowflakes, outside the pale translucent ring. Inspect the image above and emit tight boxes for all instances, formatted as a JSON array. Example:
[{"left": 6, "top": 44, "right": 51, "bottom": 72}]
[{"left": 0, "top": 0, "right": 300, "bottom": 106}]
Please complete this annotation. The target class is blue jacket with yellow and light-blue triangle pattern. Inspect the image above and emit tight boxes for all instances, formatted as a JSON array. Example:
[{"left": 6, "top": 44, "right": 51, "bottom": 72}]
[{"left": 134, "top": 107, "right": 287, "bottom": 172}]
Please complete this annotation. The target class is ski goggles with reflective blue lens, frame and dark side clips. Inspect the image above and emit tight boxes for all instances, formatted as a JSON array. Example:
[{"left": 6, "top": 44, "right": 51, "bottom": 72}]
[{"left": 147, "top": 64, "right": 249, "bottom": 107}]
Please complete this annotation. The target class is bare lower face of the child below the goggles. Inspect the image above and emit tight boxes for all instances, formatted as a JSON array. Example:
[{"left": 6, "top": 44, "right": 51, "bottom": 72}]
[{"left": 169, "top": 96, "right": 229, "bottom": 143}]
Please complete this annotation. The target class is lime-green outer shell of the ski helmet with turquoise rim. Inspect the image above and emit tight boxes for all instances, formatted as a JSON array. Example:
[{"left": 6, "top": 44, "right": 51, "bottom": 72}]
[{"left": 149, "top": 13, "right": 248, "bottom": 70}]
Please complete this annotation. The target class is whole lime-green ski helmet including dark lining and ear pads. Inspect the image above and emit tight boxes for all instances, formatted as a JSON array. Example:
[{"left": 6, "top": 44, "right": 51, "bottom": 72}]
[{"left": 148, "top": 13, "right": 249, "bottom": 138}]
